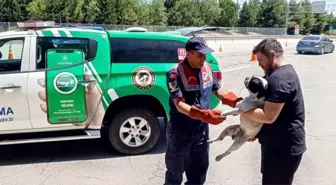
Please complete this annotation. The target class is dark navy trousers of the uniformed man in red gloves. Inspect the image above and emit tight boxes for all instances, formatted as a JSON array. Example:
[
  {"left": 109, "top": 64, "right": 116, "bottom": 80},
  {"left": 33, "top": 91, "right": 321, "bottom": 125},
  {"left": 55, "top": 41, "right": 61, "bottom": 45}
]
[{"left": 164, "top": 123, "right": 209, "bottom": 185}]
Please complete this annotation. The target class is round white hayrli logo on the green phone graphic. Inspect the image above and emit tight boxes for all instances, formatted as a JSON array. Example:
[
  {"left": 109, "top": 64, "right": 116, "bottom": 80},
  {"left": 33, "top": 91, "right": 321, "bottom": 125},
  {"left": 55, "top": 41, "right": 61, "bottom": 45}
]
[{"left": 54, "top": 72, "right": 78, "bottom": 94}]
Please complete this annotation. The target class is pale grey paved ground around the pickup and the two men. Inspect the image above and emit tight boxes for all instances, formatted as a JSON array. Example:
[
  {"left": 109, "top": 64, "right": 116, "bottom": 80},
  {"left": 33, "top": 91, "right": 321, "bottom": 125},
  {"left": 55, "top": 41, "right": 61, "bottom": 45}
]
[{"left": 0, "top": 41, "right": 336, "bottom": 185}]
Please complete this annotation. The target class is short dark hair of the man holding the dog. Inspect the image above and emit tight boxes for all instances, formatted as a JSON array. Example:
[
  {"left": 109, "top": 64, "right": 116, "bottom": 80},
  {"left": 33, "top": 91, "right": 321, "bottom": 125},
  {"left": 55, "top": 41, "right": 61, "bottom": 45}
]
[{"left": 252, "top": 38, "right": 284, "bottom": 57}]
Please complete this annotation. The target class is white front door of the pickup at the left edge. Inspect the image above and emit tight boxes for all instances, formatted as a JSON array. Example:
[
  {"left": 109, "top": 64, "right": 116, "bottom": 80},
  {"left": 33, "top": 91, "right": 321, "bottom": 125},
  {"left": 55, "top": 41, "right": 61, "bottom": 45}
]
[{"left": 0, "top": 36, "right": 32, "bottom": 131}]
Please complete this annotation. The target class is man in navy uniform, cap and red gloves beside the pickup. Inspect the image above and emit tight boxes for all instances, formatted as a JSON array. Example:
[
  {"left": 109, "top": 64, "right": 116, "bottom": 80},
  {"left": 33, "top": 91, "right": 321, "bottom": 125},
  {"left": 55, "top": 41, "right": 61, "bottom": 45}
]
[{"left": 165, "top": 37, "right": 242, "bottom": 185}]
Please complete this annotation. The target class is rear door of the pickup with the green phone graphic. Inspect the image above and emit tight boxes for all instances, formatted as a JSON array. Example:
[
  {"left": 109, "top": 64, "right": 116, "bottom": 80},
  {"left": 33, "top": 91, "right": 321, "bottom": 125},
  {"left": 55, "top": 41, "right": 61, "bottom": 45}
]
[{"left": 28, "top": 32, "right": 101, "bottom": 130}]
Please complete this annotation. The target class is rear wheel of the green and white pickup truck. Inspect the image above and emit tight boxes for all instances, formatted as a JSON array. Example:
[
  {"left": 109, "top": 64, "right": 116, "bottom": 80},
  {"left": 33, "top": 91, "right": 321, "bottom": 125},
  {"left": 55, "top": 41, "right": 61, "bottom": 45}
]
[{"left": 108, "top": 108, "right": 160, "bottom": 155}]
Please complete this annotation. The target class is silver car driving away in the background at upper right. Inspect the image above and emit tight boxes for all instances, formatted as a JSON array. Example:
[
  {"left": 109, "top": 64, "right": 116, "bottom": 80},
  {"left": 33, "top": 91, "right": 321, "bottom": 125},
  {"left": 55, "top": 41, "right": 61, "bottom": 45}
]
[{"left": 296, "top": 35, "right": 335, "bottom": 55}]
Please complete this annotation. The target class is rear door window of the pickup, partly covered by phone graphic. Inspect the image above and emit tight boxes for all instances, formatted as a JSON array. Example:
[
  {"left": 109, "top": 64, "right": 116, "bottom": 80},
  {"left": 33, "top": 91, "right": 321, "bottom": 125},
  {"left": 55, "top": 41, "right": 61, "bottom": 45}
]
[{"left": 36, "top": 37, "right": 89, "bottom": 69}]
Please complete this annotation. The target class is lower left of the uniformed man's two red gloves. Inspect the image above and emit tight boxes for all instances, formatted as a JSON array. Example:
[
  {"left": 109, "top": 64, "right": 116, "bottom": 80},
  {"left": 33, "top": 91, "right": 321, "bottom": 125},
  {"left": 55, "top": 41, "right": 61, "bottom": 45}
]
[{"left": 189, "top": 105, "right": 226, "bottom": 125}]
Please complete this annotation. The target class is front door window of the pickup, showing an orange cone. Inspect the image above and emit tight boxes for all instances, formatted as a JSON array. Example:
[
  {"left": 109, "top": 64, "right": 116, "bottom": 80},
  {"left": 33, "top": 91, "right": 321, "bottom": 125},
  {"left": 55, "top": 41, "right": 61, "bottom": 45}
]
[{"left": 0, "top": 38, "right": 24, "bottom": 73}]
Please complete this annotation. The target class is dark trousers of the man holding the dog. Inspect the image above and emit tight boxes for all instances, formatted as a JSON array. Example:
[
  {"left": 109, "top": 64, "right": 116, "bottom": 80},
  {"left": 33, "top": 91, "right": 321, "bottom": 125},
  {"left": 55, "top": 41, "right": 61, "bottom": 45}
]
[{"left": 261, "top": 145, "right": 303, "bottom": 185}]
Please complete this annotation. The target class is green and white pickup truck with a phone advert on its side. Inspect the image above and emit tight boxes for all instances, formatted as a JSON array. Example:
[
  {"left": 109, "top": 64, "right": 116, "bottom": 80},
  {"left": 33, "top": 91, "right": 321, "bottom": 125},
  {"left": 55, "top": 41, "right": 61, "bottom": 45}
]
[{"left": 0, "top": 22, "right": 221, "bottom": 155}]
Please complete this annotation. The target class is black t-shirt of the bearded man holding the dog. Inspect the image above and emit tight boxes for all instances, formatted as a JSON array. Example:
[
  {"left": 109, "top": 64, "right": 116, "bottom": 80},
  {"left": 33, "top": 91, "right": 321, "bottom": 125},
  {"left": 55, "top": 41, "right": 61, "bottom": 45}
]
[{"left": 257, "top": 64, "right": 306, "bottom": 155}]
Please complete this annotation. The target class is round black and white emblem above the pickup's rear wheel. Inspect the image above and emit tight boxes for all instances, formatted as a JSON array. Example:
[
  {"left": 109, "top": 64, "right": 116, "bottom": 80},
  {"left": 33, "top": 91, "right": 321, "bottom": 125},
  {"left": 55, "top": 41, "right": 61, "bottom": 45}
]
[{"left": 132, "top": 67, "right": 155, "bottom": 90}]
